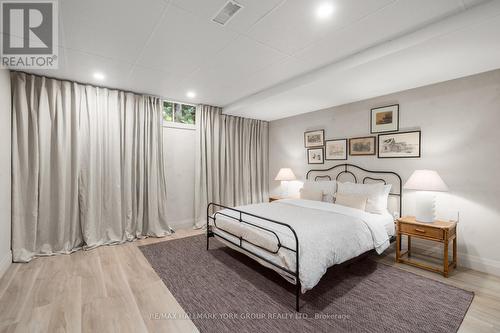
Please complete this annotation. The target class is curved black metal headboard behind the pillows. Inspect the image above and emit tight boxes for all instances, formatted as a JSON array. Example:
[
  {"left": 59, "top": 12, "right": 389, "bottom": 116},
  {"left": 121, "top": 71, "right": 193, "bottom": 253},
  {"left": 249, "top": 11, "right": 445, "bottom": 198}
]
[{"left": 306, "top": 163, "right": 403, "bottom": 216}]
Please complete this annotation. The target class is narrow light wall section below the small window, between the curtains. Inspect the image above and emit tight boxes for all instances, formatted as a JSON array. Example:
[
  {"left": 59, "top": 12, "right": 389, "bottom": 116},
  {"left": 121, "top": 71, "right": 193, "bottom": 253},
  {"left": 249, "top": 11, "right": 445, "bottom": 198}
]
[{"left": 163, "top": 127, "right": 195, "bottom": 229}]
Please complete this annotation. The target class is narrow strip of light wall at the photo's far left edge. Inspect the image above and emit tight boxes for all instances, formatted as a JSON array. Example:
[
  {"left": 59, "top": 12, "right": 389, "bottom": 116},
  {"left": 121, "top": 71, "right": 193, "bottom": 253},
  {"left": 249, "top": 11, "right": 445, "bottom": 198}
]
[{"left": 0, "top": 69, "right": 12, "bottom": 277}]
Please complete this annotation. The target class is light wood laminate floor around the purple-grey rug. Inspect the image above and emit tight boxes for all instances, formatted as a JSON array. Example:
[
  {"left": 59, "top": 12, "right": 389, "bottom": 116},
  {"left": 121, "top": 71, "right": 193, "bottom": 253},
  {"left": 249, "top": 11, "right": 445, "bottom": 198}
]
[{"left": 0, "top": 230, "right": 500, "bottom": 332}]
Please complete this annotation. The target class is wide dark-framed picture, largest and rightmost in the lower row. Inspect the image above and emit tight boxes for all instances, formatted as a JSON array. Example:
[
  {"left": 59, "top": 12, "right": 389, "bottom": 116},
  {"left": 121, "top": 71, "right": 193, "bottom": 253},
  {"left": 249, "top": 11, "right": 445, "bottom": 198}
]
[{"left": 378, "top": 131, "right": 422, "bottom": 158}]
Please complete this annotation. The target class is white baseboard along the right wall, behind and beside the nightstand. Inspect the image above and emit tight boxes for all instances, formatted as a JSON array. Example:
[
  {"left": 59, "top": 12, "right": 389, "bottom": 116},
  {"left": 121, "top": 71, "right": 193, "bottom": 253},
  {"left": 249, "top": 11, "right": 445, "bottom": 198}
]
[{"left": 403, "top": 239, "right": 500, "bottom": 276}]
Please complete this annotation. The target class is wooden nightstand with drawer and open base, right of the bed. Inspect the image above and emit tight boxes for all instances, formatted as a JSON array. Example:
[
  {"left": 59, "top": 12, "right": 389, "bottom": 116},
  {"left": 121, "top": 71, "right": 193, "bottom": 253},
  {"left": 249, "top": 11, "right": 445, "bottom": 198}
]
[{"left": 396, "top": 216, "right": 457, "bottom": 277}]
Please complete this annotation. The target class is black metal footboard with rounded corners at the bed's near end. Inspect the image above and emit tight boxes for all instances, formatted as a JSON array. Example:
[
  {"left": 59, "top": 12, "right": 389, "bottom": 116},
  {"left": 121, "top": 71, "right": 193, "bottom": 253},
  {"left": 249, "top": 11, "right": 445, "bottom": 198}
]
[{"left": 207, "top": 202, "right": 300, "bottom": 311}]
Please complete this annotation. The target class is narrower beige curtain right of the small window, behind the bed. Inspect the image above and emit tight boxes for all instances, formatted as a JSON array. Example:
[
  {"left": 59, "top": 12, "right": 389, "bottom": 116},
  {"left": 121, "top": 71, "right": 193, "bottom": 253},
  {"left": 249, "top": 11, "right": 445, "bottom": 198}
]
[{"left": 195, "top": 105, "right": 269, "bottom": 227}]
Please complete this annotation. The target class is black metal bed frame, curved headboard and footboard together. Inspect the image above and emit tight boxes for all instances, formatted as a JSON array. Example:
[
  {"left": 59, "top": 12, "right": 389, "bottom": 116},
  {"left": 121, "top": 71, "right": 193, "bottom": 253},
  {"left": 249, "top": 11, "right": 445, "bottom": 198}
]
[{"left": 207, "top": 163, "right": 403, "bottom": 312}]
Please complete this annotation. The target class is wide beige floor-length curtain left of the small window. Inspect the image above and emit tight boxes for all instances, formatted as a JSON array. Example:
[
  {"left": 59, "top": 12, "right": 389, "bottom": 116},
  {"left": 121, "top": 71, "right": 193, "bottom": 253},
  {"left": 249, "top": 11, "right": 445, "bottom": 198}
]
[{"left": 11, "top": 72, "right": 171, "bottom": 262}]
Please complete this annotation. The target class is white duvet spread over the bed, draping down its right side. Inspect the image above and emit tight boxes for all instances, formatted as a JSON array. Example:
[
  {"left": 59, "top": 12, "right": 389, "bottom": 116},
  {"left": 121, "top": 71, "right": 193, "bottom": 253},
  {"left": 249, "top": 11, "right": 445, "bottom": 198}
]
[{"left": 214, "top": 199, "right": 390, "bottom": 293}]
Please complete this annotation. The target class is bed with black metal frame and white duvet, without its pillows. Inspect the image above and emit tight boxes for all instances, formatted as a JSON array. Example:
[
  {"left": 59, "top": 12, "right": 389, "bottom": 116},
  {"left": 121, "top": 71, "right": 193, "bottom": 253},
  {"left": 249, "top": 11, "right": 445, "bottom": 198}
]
[{"left": 207, "top": 164, "right": 402, "bottom": 311}]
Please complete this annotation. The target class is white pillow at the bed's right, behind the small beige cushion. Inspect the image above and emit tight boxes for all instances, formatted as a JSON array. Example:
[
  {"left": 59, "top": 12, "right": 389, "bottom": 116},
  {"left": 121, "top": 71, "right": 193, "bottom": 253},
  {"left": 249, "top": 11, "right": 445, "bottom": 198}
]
[{"left": 337, "top": 183, "right": 392, "bottom": 214}]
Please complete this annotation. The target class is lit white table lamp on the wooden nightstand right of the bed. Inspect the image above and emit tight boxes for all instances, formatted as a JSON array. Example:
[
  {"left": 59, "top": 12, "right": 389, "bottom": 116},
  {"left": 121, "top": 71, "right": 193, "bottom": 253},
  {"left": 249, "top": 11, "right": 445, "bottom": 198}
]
[{"left": 404, "top": 170, "right": 448, "bottom": 223}]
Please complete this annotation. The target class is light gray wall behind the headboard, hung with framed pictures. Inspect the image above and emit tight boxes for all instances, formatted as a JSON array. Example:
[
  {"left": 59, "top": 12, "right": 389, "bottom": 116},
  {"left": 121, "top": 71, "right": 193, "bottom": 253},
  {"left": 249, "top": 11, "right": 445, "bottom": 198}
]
[{"left": 269, "top": 70, "right": 500, "bottom": 275}]
